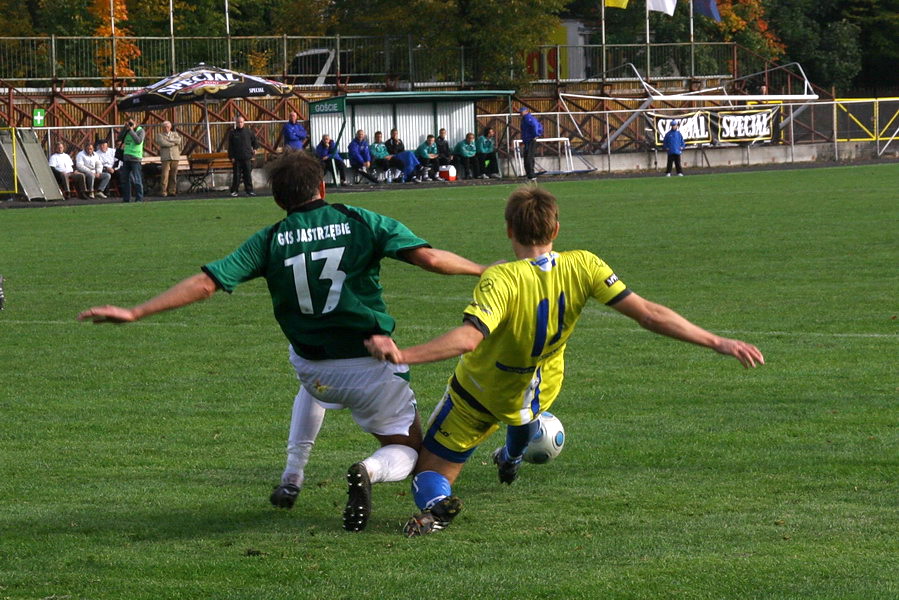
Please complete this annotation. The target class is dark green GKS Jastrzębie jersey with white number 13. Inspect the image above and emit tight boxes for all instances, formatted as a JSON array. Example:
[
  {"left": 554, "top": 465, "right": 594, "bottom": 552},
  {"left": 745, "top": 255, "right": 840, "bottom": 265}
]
[{"left": 203, "top": 200, "right": 430, "bottom": 360}]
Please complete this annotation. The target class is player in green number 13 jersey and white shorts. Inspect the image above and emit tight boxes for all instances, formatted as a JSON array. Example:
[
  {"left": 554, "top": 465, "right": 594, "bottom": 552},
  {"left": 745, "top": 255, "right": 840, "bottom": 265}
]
[{"left": 78, "top": 152, "right": 484, "bottom": 531}]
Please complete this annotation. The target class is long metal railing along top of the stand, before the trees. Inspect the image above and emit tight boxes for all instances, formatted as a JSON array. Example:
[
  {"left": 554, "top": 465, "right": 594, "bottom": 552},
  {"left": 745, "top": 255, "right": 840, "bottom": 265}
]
[{"left": 0, "top": 35, "right": 737, "bottom": 88}]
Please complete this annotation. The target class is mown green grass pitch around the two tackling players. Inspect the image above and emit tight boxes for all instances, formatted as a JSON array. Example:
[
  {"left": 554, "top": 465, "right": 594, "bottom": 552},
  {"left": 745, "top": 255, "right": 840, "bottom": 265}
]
[{"left": 0, "top": 164, "right": 899, "bottom": 600}]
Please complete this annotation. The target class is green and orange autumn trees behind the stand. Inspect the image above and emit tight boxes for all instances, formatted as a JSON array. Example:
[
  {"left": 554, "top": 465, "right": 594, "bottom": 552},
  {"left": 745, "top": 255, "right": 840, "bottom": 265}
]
[{"left": 0, "top": 0, "right": 899, "bottom": 90}]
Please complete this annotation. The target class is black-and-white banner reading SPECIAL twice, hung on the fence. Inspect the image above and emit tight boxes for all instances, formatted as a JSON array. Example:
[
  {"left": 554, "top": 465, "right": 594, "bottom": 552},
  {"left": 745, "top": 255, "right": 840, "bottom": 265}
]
[{"left": 646, "top": 106, "right": 780, "bottom": 146}]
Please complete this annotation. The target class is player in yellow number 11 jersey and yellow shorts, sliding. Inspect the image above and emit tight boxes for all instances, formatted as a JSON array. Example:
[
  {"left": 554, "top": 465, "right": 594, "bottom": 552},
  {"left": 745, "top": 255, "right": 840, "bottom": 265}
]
[{"left": 366, "top": 187, "right": 764, "bottom": 536}]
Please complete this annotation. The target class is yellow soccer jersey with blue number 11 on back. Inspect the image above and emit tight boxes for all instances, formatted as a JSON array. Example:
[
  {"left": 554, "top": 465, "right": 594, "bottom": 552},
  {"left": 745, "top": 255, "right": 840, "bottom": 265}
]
[{"left": 453, "top": 250, "right": 630, "bottom": 425}]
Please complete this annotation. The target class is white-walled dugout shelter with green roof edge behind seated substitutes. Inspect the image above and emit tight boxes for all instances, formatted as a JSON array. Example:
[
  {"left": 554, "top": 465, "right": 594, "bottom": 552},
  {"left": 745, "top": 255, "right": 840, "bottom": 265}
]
[{"left": 309, "top": 90, "right": 515, "bottom": 152}]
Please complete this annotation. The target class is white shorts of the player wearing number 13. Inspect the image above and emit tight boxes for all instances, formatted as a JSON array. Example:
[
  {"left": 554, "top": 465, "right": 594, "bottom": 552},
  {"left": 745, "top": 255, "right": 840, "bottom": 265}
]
[{"left": 290, "top": 346, "right": 416, "bottom": 435}]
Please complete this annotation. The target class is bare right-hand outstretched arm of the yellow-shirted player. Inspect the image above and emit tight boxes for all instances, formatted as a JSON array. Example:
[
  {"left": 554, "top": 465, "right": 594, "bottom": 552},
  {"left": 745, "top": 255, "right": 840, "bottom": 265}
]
[{"left": 613, "top": 293, "right": 765, "bottom": 368}]
